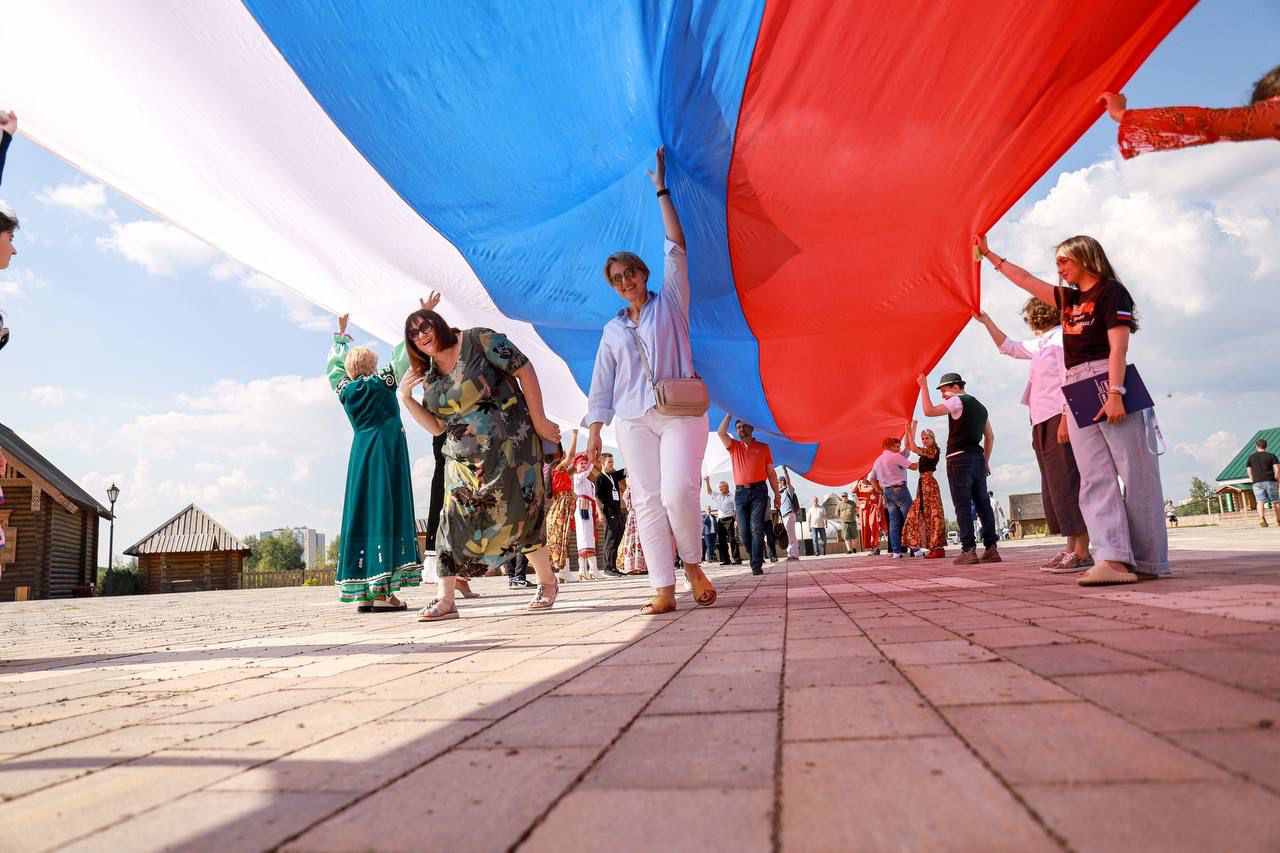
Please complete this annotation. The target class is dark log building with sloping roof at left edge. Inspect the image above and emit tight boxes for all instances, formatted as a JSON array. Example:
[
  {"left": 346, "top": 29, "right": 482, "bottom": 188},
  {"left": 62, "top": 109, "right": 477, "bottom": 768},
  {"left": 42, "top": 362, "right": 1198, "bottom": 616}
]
[{"left": 0, "top": 424, "right": 111, "bottom": 601}]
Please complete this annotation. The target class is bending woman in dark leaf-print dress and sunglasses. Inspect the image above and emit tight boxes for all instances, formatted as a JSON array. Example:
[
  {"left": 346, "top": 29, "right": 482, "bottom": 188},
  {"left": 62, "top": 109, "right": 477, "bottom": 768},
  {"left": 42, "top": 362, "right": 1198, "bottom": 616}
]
[{"left": 401, "top": 306, "right": 561, "bottom": 621}]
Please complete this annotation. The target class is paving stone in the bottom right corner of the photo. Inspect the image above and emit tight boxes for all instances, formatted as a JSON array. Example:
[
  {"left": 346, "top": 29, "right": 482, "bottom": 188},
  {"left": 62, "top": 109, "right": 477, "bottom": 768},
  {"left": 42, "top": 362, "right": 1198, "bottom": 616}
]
[{"left": 1019, "top": 781, "right": 1280, "bottom": 853}]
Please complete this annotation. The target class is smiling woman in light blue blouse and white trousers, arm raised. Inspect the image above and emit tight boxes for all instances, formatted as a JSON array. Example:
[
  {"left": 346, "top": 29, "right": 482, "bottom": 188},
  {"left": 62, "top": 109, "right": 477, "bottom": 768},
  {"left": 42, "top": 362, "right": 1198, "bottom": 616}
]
[{"left": 582, "top": 149, "right": 716, "bottom": 615}]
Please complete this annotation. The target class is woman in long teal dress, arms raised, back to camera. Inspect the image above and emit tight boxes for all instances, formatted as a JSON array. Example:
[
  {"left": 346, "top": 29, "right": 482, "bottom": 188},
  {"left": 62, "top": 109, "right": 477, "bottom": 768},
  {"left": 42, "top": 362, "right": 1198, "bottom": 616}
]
[{"left": 329, "top": 308, "right": 422, "bottom": 612}]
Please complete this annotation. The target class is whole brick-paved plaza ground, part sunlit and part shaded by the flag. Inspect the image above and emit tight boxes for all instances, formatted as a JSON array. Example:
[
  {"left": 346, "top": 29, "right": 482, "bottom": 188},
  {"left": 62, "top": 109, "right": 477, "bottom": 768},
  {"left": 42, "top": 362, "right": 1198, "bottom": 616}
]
[{"left": 0, "top": 529, "right": 1280, "bottom": 853}]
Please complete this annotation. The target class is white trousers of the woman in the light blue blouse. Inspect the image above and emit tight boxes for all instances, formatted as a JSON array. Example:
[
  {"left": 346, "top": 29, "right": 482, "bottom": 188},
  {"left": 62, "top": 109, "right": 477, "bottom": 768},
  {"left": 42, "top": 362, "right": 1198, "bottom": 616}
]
[{"left": 617, "top": 409, "right": 707, "bottom": 589}]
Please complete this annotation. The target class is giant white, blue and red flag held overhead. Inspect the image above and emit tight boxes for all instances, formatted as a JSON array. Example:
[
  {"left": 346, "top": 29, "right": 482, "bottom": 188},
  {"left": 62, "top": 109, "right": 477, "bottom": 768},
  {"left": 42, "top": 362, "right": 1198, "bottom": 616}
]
[{"left": 0, "top": 0, "right": 1193, "bottom": 484}]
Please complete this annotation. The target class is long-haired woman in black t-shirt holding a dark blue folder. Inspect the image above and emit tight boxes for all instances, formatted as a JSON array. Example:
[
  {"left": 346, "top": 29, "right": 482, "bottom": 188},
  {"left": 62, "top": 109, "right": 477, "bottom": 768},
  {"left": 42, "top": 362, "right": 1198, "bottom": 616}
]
[{"left": 978, "top": 236, "right": 1169, "bottom": 587}]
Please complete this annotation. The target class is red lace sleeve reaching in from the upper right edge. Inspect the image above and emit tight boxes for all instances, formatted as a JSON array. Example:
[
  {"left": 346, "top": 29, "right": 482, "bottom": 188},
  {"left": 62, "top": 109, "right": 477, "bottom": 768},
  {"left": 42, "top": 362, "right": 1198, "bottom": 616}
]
[{"left": 1119, "top": 97, "right": 1280, "bottom": 160}]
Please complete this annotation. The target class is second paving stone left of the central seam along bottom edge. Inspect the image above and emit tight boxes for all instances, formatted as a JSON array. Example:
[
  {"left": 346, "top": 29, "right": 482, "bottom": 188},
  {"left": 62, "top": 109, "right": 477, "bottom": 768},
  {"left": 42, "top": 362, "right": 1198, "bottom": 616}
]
[{"left": 284, "top": 747, "right": 599, "bottom": 853}]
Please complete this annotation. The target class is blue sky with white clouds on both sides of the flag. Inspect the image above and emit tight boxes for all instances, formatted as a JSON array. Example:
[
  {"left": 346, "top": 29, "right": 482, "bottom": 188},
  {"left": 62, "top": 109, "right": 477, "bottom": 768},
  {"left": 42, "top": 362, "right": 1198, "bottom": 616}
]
[{"left": 0, "top": 0, "right": 1280, "bottom": 563}]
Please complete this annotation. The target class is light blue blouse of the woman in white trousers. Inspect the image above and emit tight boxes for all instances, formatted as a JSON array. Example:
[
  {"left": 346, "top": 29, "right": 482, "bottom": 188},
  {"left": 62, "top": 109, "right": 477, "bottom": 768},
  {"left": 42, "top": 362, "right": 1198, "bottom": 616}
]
[{"left": 582, "top": 240, "right": 694, "bottom": 427}]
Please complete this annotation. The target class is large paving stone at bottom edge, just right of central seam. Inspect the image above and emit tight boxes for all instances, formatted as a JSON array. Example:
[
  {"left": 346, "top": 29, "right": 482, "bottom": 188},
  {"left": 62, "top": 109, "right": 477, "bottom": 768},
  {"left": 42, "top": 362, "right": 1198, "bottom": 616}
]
[{"left": 782, "top": 736, "right": 1059, "bottom": 853}]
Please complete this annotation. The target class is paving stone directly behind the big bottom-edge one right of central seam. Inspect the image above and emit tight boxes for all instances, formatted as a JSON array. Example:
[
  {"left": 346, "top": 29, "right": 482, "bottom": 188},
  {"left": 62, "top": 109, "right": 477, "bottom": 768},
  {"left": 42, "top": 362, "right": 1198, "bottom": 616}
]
[{"left": 782, "top": 684, "right": 947, "bottom": 740}]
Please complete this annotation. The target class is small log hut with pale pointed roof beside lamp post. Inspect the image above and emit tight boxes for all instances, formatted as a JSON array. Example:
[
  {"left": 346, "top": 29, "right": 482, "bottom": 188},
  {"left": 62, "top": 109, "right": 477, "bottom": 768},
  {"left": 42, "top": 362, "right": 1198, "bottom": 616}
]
[{"left": 124, "top": 503, "right": 250, "bottom": 593}]
